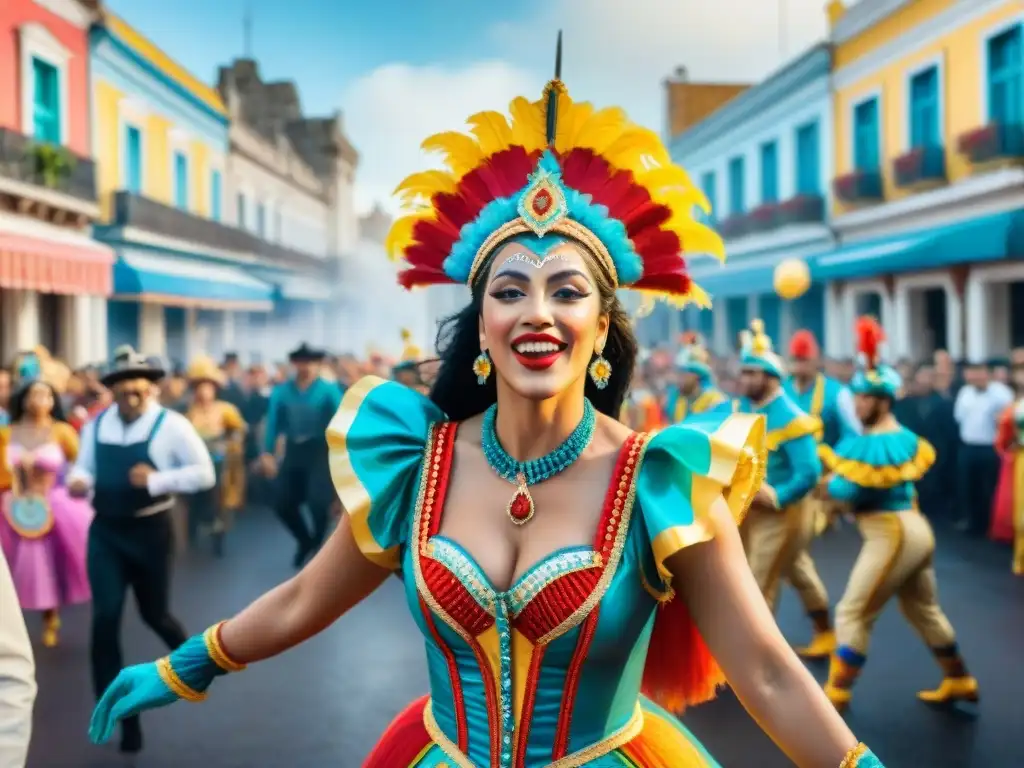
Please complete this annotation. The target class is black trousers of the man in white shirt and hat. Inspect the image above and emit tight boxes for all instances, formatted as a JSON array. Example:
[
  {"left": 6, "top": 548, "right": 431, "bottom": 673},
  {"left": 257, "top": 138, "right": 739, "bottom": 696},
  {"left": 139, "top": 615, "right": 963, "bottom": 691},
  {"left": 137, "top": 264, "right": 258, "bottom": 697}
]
[{"left": 88, "top": 512, "right": 187, "bottom": 720}]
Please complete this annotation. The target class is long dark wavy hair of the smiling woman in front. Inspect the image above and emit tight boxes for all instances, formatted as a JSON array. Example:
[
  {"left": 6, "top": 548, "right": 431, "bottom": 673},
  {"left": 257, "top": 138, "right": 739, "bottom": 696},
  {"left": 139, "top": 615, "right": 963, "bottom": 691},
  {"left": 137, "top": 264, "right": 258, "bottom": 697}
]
[{"left": 430, "top": 244, "right": 637, "bottom": 421}]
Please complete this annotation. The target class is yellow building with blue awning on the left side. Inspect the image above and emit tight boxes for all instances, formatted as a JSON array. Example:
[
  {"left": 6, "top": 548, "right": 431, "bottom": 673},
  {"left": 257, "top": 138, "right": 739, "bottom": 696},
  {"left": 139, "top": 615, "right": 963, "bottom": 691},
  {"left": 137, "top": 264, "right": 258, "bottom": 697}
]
[{"left": 90, "top": 13, "right": 273, "bottom": 361}]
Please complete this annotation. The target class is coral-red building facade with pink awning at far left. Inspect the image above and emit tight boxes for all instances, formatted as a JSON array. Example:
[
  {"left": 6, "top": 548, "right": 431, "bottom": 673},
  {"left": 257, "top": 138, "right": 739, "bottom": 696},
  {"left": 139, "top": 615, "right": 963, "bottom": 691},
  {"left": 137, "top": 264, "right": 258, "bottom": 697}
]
[{"left": 0, "top": 0, "right": 114, "bottom": 366}]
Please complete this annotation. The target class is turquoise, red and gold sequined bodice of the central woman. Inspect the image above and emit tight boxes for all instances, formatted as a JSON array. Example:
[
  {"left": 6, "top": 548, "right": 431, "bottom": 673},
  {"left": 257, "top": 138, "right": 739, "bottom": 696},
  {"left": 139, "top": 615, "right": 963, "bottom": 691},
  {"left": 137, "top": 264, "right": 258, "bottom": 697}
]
[{"left": 402, "top": 424, "right": 656, "bottom": 768}]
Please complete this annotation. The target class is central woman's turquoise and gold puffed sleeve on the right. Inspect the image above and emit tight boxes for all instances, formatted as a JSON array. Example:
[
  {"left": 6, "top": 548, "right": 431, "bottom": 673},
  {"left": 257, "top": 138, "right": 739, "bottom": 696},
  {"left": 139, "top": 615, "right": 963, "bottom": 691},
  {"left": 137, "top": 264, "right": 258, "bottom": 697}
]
[{"left": 637, "top": 413, "right": 767, "bottom": 583}]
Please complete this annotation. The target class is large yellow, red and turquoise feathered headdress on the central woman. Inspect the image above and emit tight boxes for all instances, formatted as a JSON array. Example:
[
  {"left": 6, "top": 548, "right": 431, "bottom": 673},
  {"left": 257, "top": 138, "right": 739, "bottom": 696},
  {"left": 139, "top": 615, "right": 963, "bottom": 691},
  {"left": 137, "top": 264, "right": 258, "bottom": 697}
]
[{"left": 386, "top": 33, "right": 724, "bottom": 305}]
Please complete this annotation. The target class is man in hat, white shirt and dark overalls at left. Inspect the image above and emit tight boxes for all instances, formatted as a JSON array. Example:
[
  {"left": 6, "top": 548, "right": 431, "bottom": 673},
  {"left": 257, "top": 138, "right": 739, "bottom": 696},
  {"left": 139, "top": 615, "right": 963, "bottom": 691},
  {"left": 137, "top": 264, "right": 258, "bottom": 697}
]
[{"left": 68, "top": 346, "right": 216, "bottom": 753}]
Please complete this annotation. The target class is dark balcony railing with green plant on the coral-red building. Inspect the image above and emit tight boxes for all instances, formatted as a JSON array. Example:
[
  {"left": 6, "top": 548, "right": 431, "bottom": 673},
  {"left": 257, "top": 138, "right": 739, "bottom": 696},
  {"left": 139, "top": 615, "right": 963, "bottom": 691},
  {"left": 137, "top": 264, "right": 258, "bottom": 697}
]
[{"left": 0, "top": 128, "right": 97, "bottom": 203}]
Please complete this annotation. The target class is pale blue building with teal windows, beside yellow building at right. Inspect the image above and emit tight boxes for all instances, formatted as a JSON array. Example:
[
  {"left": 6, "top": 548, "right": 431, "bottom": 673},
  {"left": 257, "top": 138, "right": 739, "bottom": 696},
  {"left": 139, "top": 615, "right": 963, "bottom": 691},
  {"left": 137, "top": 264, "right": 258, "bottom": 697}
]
[{"left": 669, "top": 44, "right": 834, "bottom": 352}]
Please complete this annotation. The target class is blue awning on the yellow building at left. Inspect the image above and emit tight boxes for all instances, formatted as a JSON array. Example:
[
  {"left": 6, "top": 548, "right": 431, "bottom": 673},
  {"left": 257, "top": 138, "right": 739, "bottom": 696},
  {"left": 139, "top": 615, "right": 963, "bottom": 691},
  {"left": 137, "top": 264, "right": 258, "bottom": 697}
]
[{"left": 114, "top": 250, "right": 273, "bottom": 312}]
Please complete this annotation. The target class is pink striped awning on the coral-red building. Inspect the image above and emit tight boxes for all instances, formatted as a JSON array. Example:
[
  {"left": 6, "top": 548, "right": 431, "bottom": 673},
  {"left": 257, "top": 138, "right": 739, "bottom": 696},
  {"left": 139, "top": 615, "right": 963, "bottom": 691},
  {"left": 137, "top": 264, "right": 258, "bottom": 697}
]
[{"left": 0, "top": 232, "right": 114, "bottom": 296}]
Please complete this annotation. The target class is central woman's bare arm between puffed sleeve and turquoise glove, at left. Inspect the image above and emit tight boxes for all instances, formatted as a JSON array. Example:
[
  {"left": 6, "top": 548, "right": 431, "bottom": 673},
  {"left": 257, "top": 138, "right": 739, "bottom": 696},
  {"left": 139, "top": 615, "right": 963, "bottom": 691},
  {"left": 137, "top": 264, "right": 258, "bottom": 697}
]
[{"left": 220, "top": 514, "right": 390, "bottom": 664}]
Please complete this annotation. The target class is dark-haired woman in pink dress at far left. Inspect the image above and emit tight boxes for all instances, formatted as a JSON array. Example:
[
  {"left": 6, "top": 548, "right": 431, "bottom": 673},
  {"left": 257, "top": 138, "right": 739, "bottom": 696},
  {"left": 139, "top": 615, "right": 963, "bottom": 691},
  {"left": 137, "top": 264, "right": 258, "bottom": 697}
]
[{"left": 0, "top": 356, "right": 92, "bottom": 647}]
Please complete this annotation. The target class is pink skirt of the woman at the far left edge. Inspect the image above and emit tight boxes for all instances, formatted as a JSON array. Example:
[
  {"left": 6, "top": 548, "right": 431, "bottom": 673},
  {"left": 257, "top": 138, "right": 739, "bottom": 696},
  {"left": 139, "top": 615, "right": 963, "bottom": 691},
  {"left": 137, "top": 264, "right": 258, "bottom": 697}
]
[{"left": 0, "top": 487, "right": 93, "bottom": 610}]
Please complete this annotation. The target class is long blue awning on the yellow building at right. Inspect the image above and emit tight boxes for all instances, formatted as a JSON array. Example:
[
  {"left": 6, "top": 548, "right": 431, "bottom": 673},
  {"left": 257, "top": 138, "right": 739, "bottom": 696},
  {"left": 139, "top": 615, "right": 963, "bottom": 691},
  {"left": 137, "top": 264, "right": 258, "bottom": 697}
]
[{"left": 812, "top": 210, "right": 1024, "bottom": 281}]
